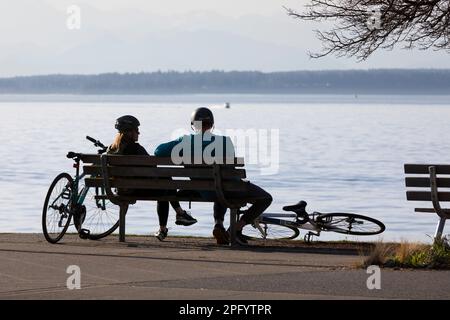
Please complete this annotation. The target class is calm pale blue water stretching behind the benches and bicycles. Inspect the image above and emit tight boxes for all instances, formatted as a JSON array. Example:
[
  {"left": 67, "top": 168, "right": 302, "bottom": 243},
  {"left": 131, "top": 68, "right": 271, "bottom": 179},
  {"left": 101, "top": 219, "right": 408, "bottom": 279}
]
[{"left": 0, "top": 95, "right": 450, "bottom": 241}]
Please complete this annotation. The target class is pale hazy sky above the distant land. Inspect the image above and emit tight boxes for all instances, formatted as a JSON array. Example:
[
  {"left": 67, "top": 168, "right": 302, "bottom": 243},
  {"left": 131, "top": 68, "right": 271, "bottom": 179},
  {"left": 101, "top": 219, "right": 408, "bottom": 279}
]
[{"left": 0, "top": 0, "right": 450, "bottom": 76}]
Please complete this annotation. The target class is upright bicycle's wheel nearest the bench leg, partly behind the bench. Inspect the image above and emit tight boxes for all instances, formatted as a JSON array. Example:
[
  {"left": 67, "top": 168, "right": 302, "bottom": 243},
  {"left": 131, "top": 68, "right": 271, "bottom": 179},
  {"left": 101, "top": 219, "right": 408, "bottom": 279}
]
[{"left": 74, "top": 187, "right": 120, "bottom": 240}]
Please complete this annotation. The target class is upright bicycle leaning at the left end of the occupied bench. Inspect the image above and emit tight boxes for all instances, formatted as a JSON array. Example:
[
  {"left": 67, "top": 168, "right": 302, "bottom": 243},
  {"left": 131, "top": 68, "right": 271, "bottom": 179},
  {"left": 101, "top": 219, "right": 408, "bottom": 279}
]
[{"left": 42, "top": 136, "right": 120, "bottom": 243}]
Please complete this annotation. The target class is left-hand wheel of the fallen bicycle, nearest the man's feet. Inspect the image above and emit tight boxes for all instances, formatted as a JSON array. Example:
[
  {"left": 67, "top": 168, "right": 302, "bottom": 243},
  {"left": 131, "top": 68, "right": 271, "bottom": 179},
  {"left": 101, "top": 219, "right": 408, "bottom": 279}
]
[{"left": 242, "top": 219, "right": 300, "bottom": 240}]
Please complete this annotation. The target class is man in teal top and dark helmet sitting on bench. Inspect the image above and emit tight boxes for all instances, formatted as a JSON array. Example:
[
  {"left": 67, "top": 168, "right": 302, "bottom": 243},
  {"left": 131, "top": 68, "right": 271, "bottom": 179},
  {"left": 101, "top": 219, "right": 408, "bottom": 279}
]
[{"left": 155, "top": 108, "right": 272, "bottom": 244}]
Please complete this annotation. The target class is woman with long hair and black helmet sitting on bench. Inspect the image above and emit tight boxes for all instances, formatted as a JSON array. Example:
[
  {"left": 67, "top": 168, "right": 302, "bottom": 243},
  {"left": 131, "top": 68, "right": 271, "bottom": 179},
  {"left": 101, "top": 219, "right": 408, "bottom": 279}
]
[{"left": 107, "top": 115, "right": 197, "bottom": 241}]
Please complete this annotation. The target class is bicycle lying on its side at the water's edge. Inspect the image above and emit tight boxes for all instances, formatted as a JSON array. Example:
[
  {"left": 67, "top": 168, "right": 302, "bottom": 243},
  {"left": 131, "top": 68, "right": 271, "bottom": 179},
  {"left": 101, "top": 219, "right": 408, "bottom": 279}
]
[{"left": 242, "top": 201, "right": 385, "bottom": 242}]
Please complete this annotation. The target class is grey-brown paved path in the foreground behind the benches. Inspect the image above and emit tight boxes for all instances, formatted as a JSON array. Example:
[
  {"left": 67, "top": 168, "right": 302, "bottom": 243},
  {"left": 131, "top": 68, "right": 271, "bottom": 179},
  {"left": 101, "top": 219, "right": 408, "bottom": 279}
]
[{"left": 0, "top": 234, "right": 450, "bottom": 300}]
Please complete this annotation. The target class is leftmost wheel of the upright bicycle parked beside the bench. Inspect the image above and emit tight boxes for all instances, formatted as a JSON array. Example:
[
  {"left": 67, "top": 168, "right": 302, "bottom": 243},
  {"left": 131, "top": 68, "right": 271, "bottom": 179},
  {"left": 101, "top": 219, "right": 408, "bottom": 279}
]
[{"left": 42, "top": 173, "right": 73, "bottom": 243}]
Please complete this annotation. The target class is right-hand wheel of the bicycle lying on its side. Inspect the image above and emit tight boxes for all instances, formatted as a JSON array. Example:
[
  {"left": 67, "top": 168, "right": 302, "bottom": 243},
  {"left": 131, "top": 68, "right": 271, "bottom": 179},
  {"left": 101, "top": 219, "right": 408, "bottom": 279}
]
[{"left": 317, "top": 213, "right": 386, "bottom": 236}]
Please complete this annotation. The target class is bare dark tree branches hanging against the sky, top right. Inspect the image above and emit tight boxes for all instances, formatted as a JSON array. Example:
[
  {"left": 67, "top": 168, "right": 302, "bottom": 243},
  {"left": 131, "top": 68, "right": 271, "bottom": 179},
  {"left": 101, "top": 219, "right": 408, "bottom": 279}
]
[{"left": 285, "top": 0, "right": 450, "bottom": 60}]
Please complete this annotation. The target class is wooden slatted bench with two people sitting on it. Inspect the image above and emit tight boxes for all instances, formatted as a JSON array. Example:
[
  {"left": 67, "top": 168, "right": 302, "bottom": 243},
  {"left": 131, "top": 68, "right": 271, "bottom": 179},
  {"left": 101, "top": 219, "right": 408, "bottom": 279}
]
[{"left": 80, "top": 154, "right": 253, "bottom": 245}]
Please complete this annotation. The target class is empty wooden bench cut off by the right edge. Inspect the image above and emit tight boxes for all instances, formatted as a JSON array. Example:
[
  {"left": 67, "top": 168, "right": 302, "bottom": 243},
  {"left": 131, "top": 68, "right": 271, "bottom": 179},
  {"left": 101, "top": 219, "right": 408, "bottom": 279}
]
[{"left": 405, "top": 164, "right": 450, "bottom": 239}]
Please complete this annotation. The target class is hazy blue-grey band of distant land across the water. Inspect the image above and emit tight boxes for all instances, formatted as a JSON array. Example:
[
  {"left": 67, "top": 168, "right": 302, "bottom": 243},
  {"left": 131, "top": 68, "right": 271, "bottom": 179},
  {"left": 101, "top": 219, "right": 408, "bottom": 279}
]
[{"left": 0, "top": 69, "right": 450, "bottom": 94}]
